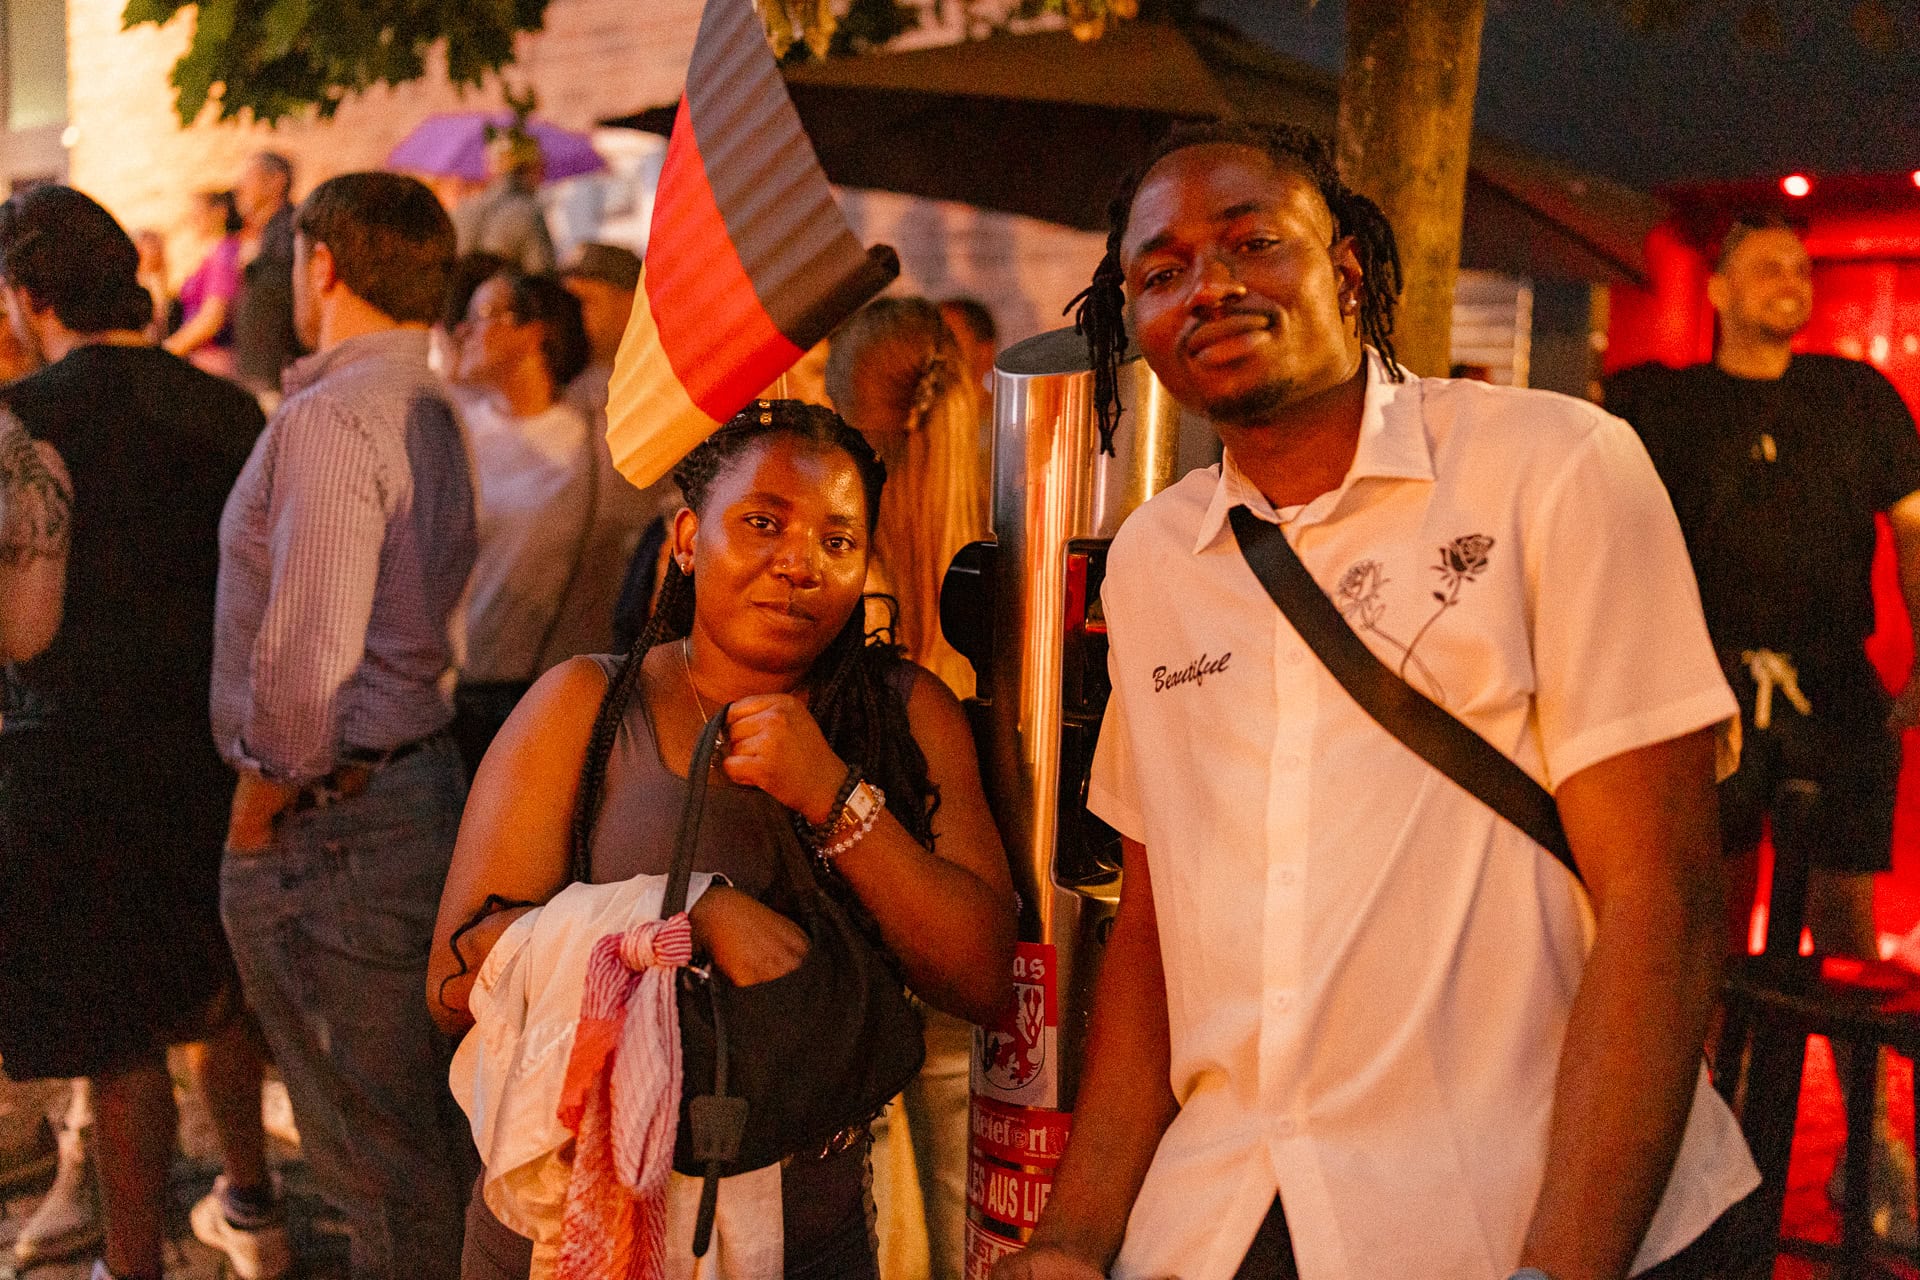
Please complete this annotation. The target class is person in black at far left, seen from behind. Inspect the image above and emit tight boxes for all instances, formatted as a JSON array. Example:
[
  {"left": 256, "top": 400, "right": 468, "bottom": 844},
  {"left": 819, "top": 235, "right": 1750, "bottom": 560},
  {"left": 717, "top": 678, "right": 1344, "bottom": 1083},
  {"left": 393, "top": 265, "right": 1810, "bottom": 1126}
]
[{"left": 0, "top": 186, "right": 288, "bottom": 1280}]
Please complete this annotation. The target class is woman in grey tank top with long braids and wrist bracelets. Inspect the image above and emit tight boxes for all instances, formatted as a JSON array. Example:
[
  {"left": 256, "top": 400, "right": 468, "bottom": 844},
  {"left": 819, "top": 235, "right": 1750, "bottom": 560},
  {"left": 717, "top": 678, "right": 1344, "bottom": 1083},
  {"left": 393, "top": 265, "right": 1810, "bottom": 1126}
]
[{"left": 428, "top": 401, "right": 1014, "bottom": 1276}]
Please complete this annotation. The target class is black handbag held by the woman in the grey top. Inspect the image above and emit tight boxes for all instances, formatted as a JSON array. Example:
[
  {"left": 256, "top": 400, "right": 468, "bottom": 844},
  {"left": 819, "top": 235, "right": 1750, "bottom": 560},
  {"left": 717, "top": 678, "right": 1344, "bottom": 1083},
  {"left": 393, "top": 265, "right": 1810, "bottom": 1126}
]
[{"left": 660, "top": 706, "right": 925, "bottom": 1257}]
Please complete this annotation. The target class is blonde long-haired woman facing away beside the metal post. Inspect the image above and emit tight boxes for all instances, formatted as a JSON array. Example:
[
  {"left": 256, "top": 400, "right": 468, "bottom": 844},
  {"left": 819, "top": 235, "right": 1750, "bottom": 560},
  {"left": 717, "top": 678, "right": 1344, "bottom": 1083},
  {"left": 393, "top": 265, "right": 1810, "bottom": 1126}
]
[{"left": 826, "top": 297, "right": 987, "bottom": 1280}]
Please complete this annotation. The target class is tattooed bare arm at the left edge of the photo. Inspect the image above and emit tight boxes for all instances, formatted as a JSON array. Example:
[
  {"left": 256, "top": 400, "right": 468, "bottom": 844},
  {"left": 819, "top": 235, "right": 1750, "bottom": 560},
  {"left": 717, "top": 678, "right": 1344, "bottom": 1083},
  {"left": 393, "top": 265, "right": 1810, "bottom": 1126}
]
[{"left": 0, "top": 413, "right": 73, "bottom": 662}]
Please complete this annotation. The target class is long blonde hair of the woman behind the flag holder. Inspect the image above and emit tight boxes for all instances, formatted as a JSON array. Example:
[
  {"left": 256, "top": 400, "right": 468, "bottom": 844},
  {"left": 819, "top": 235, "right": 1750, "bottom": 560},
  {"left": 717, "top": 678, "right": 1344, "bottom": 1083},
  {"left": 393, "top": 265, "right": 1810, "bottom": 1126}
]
[{"left": 828, "top": 297, "right": 987, "bottom": 699}]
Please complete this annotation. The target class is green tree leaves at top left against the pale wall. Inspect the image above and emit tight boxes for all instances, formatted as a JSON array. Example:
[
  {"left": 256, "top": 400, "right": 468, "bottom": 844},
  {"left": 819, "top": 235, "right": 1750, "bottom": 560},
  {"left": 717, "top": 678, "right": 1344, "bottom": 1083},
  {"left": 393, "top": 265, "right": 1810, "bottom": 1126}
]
[{"left": 121, "top": 0, "right": 547, "bottom": 125}]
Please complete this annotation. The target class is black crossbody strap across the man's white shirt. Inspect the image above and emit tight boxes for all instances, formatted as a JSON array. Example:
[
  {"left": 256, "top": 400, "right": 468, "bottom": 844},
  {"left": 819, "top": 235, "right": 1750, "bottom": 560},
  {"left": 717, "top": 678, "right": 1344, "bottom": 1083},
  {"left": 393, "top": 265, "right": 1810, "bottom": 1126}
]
[{"left": 1227, "top": 507, "right": 1582, "bottom": 879}]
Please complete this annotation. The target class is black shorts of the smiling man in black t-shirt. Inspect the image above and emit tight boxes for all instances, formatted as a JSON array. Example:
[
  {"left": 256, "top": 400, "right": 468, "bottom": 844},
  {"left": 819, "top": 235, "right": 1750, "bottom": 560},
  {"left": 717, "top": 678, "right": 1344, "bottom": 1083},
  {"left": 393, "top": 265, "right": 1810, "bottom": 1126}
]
[{"left": 1720, "top": 654, "right": 1901, "bottom": 873}]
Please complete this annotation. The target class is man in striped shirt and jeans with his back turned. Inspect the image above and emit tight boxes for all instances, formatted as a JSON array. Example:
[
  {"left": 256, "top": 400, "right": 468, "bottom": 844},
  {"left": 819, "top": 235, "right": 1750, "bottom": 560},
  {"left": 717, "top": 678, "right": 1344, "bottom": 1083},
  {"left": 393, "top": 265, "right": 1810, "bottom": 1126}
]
[{"left": 213, "top": 173, "right": 474, "bottom": 1280}]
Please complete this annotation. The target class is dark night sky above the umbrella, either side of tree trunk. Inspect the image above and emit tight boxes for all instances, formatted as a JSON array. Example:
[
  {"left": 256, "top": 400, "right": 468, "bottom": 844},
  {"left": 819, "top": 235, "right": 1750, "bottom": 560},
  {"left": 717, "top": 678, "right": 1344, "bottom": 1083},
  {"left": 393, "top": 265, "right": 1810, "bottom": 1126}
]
[{"left": 1202, "top": 0, "right": 1920, "bottom": 188}]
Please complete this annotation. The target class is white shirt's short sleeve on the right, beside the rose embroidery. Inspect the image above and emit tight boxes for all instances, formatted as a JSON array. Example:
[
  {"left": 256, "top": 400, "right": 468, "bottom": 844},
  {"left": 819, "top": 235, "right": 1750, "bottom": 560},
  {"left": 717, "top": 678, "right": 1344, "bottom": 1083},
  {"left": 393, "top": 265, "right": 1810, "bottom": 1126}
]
[{"left": 1526, "top": 416, "right": 1740, "bottom": 789}]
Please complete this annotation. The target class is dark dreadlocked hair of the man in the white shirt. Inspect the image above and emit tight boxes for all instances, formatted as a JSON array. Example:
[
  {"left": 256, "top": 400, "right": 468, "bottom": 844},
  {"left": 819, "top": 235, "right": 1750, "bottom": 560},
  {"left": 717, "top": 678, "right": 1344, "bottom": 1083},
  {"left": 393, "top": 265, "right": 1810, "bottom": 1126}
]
[{"left": 1066, "top": 121, "right": 1404, "bottom": 453}]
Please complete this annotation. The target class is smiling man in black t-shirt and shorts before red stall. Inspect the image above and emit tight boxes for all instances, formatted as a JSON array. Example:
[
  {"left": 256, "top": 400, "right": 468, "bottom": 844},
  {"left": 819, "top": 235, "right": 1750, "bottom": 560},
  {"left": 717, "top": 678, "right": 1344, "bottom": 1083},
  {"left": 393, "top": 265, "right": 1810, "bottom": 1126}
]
[{"left": 1607, "top": 221, "right": 1920, "bottom": 1226}]
